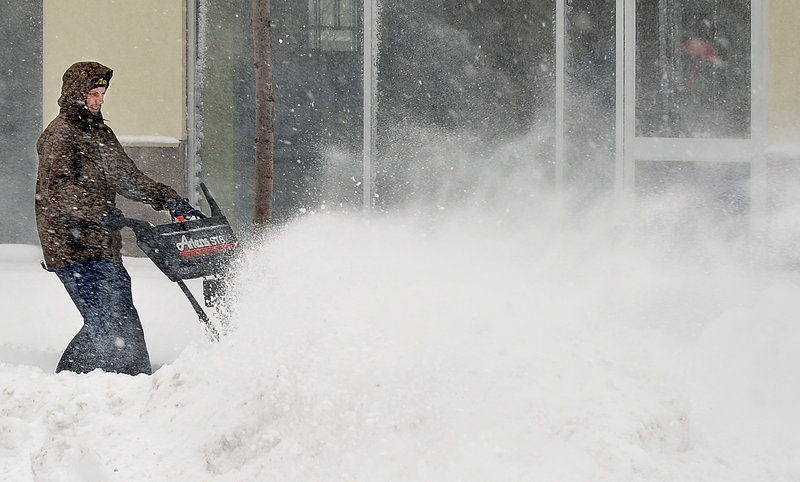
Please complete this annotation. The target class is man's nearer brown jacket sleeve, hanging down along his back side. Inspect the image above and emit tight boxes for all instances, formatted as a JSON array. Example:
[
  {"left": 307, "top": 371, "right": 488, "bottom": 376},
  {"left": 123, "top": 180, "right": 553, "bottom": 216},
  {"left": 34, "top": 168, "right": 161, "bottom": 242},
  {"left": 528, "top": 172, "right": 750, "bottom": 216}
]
[{"left": 37, "top": 131, "right": 104, "bottom": 223}]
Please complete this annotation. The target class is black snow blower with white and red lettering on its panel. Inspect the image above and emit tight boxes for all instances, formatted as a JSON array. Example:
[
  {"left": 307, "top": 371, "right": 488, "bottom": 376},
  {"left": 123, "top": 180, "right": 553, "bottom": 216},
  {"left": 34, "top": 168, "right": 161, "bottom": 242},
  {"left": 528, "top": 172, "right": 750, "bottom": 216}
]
[{"left": 119, "top": 183, "right": 237, "bottom": 340}]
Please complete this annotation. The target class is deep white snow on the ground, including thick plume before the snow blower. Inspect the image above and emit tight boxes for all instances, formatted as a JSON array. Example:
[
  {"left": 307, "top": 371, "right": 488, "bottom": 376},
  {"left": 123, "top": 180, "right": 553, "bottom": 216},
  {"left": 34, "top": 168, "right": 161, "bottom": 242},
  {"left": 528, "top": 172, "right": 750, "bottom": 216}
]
[{"left": 0, "top": 189, "right": 800, "bottom": 481}]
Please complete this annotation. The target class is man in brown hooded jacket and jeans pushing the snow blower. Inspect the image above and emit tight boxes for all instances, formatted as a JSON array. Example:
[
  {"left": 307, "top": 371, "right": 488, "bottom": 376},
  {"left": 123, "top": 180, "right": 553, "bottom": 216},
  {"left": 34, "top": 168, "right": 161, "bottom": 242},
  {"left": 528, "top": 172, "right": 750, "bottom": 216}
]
[{"left": 36, "top": 62, "right": 196, "bottom": 375}]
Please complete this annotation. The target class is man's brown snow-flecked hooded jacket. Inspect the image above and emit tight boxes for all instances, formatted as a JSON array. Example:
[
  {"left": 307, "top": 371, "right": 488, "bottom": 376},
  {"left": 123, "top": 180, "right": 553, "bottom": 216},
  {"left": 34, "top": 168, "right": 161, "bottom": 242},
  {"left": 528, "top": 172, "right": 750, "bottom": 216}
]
[{"left": 36, "top": 62, "right": 179, "bottom": 270}]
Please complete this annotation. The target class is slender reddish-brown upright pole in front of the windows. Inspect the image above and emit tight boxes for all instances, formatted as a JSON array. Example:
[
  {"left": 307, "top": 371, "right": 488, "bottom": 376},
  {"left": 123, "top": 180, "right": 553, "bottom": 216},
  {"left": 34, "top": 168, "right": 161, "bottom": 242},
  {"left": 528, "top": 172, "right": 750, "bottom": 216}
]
[{"left": 253, "top": 0, "right": 275, "bottom": 233}]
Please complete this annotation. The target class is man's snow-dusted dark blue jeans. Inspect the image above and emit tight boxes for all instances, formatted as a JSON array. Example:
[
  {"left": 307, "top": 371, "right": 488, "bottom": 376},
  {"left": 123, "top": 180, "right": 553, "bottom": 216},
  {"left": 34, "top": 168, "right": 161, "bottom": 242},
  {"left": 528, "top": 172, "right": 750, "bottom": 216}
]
[{"left": 56, "top": 260, "right": 151, "bottom": 375}]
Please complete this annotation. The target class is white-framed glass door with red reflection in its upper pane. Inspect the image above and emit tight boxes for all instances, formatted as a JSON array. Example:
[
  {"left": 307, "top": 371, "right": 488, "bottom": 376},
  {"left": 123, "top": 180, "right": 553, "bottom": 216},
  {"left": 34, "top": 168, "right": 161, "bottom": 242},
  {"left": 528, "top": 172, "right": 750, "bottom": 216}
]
[{"left": 617, "top": 0, "right": 766, "bottom": 218}]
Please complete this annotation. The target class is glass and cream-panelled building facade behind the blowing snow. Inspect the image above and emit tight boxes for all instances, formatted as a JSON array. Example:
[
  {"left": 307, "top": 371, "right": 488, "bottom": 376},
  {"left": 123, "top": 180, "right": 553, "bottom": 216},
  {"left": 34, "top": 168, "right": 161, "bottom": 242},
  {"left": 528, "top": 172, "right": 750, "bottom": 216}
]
[{"left": 0, "top": 0, "right": 800, "bottom": 243}]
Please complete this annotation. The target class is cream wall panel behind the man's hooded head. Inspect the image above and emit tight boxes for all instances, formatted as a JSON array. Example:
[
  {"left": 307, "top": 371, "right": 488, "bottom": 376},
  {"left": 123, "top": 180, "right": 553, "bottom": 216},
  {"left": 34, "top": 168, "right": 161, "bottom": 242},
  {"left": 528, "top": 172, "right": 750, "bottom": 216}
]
[{"left": 43, "top": 0, "right": 186, "bottom": 140}]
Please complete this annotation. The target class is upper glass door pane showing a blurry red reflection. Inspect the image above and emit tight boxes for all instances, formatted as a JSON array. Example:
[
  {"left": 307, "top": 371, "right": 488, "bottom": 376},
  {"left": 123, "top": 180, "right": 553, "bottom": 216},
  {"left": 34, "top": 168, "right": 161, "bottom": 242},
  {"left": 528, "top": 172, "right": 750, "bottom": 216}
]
[{"left": 636, "top": 0, "right": 751, "bottom": 138}]
